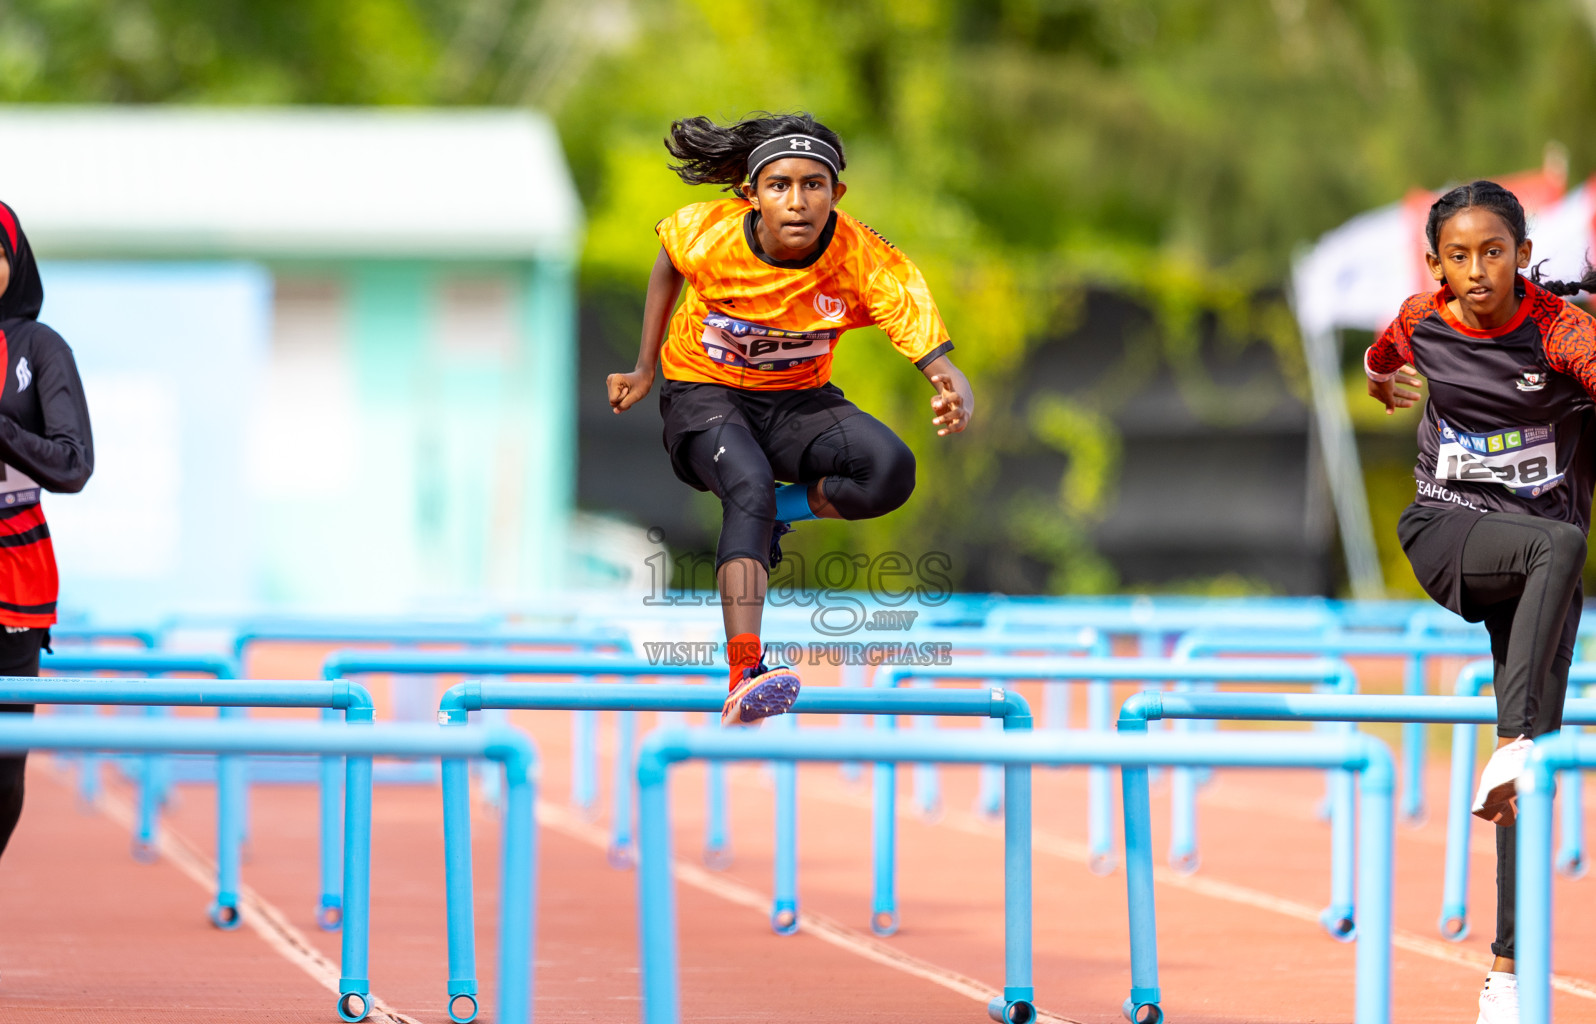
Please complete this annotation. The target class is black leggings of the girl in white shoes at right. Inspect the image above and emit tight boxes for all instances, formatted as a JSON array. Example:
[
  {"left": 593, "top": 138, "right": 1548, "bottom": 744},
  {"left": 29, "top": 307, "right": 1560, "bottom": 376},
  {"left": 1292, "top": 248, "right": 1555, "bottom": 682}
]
[{"left": 1460, "top": 512, "right": 1585, "bottom": 959}]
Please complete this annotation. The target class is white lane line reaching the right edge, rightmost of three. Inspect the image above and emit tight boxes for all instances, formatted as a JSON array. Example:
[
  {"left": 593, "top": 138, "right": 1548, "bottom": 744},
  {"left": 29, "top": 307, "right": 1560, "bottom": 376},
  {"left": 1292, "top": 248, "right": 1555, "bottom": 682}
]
[{"left": 814, "top": 771, "right": 1596, "bottom": 1000}]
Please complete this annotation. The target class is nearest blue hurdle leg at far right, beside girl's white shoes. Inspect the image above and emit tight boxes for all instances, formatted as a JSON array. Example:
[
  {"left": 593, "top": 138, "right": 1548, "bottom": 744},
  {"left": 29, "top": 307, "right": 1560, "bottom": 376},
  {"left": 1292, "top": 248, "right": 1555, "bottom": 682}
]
[{"left": 1513, "top": 772, "right": 1551, "bottom": 1024}]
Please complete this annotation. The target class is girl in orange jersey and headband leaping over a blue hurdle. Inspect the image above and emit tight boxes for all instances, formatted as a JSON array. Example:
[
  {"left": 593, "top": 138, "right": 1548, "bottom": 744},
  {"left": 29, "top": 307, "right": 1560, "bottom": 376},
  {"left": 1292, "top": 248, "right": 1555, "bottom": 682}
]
[{"left": 608, "top": 113, "right": 974, "bottom": 724}]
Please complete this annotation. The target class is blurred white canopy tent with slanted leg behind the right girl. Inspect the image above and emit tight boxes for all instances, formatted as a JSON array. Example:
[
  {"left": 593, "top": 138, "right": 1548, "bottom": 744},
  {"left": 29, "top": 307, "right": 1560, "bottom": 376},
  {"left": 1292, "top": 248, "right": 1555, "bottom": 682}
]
[{"left": 1291, "top": 172, "right": 1596, "bottom": 598}]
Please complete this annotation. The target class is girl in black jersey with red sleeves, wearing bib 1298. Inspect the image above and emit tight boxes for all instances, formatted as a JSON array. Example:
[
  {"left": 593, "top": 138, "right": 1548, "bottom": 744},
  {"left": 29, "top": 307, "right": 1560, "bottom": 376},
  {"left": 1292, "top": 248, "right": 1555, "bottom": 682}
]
[{"left": 1365, "top": 182, "right": 1596, "bottom": 1024}]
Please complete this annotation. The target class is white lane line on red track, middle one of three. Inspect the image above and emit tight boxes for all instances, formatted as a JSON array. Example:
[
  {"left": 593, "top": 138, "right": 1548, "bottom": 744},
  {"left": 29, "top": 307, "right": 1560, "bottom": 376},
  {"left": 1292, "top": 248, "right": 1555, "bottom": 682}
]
[{"left": 538, "top": 801, "right": 1079, "bottom": 1024}]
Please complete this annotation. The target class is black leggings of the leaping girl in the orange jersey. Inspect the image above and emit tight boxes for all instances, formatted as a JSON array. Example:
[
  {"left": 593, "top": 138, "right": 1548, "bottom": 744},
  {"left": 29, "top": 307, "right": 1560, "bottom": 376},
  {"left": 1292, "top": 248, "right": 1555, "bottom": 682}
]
[{"left": 681, "top": 413, "right": 915, "bottom": 569}]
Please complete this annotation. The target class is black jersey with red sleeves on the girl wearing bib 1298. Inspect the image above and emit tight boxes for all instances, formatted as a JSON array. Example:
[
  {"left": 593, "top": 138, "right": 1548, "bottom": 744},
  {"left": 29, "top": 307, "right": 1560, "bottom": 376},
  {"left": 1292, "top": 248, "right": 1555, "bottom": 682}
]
[{"left": 1366, "top": 278, "right": 1596, "bottom": 530}]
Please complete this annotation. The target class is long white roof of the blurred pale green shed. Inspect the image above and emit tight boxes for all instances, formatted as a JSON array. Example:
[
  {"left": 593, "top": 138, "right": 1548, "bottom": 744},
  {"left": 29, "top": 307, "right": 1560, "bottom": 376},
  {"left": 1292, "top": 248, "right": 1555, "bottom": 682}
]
[{"left": 0, "top": 105, "right": 581, "bottom": 258}]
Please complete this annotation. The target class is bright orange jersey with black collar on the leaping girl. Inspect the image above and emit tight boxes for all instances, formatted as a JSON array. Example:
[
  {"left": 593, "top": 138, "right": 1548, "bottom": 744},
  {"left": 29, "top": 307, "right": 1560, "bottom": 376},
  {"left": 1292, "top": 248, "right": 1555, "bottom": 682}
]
[{"left": 654, "top": 199, "right": 953, "bottom": 391}]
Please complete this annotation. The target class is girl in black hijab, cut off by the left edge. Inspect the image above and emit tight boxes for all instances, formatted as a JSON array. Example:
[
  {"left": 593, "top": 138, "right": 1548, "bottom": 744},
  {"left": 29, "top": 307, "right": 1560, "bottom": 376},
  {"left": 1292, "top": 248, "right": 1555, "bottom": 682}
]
[{"left": 0, "top": 203, "right": 94, "bottom": 853}]
